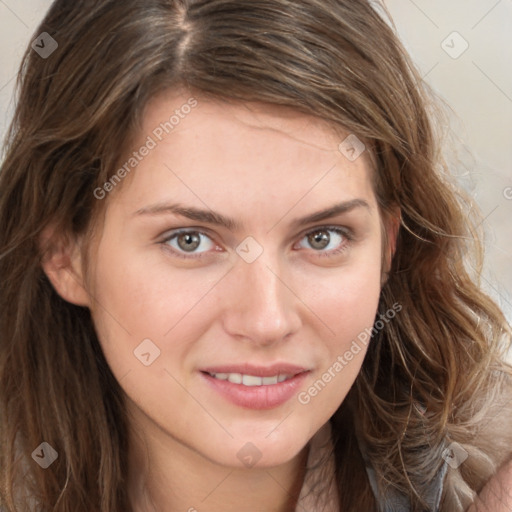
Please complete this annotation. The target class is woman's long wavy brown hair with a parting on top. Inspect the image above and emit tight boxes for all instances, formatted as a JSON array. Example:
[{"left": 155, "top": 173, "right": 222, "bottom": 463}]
[{"left": 0, "top": 0, "right": 512, "bottom": 512}]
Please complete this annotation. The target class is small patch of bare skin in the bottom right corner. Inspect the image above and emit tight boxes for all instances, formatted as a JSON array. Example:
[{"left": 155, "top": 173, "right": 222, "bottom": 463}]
[{"left": 467, "top": 460, "right": 512, "bottom": 512}]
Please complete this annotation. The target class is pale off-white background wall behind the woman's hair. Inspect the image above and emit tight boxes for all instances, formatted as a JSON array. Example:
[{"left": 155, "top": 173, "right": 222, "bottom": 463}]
[{"left": 0, "top": 0, "right": 512, "bottom": 328}]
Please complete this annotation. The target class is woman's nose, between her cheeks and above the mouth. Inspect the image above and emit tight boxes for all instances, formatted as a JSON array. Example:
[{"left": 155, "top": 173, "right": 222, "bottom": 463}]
[{"left": 223, "top": 252, "right": 301, "bottom": 346}]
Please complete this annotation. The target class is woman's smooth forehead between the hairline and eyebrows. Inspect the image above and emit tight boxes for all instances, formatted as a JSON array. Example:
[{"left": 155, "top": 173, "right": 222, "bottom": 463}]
[{"left": 105, "top": 91, "right": 372, "bottom": 218}]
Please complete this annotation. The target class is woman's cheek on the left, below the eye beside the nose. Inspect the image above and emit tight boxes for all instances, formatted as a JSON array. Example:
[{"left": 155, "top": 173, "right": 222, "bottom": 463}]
[{"left": 87, "top": 243, "right": 216, "bottom": 377}]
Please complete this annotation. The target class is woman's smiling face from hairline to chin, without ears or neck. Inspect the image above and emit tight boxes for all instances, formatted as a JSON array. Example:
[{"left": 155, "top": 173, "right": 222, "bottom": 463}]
[{"left": 84, "top": 93, "right": 390, "bottom": 467}]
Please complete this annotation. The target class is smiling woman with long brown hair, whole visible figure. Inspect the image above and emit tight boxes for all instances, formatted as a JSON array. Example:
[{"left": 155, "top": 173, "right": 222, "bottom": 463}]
[{"left": 0, "top": 0, "right": 512, "bottom": 512}]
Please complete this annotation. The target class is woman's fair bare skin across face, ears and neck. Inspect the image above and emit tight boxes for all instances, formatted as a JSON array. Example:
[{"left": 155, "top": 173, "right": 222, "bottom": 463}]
[{"left": 45, "top": 91, "right": 397, "bottom": 512}]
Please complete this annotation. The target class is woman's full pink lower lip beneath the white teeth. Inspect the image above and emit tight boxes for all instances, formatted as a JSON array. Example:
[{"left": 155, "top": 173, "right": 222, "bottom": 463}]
[{"left": 201, "top": 372, "right": 309, "bottom": 410}]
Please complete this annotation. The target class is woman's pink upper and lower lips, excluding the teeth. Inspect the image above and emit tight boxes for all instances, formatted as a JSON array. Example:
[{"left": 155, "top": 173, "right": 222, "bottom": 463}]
[{"left": 200, "top": 364, "right": 309, "bottom": 410}]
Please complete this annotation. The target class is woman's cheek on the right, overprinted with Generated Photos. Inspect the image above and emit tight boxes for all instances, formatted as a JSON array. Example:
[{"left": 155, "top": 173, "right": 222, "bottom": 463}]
[{"left": 297, "top": 243, "right": 381, "bottom": 410}]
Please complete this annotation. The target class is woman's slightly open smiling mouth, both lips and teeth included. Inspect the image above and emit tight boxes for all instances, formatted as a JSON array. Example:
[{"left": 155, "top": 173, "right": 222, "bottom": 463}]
[{"left": 200, "top": 364, "right": 310, "bottom": 410}]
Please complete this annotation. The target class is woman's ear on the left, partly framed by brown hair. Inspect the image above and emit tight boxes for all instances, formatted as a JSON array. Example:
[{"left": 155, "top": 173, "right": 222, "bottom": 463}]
[{"left": 39, "top": 226, "right": 90, "bottom": 307}]
